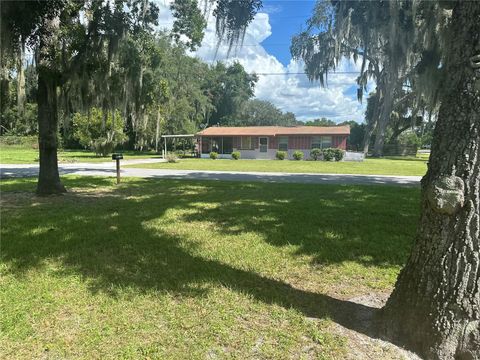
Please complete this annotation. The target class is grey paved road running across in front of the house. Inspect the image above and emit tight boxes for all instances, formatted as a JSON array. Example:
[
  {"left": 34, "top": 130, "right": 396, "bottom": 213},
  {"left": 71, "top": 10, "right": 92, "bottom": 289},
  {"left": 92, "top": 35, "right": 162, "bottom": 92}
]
[{"left": 0, "top": 160, "right": 421, "bottom": 186}]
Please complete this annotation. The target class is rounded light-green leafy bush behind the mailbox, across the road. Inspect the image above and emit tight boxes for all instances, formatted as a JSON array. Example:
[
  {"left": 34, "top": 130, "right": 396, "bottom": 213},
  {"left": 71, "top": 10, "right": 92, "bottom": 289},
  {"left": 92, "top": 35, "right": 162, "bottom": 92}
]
[{"left": 73, "top": 107, "right": 126, "bottom": 156}]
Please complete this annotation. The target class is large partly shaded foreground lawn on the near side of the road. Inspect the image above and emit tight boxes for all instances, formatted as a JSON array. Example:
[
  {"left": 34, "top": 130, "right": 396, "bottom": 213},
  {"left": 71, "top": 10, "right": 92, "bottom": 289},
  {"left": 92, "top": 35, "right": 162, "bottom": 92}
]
[{"left": 0, "top": 177, "right": 419, "bottom": 359}]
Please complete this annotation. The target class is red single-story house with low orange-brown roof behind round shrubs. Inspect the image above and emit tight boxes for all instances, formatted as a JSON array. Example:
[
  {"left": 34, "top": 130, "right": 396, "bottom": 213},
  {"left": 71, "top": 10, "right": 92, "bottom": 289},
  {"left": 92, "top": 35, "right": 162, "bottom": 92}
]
[{"left": 196, "top": 125, "right": 350, "bottom": 159}]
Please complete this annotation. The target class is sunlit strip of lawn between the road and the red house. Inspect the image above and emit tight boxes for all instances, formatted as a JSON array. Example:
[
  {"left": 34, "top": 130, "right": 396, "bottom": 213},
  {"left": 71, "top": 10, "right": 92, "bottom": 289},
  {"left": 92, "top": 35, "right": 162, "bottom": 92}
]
[{"left": 129, "top": 157, "right": 427, "bottom": 176}]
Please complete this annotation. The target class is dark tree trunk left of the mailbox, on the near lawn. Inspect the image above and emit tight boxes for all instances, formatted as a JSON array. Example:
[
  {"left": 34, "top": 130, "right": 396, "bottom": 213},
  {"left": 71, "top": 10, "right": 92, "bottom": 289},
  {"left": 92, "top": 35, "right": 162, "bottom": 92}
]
[{"left": 37, "top": 25, "right": 66, "bottom": 195}]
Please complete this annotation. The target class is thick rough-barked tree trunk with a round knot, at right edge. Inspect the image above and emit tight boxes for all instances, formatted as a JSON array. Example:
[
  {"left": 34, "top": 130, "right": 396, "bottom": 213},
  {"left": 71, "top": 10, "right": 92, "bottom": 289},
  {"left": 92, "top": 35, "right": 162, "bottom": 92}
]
[{"left": 381, "top": 1, "right": 480, "bottom": 359}]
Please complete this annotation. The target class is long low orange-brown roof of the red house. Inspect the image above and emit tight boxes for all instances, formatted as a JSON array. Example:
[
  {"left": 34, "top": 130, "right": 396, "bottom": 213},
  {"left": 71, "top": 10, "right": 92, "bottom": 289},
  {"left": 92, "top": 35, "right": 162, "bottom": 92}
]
[{"left": 197, "top": 125, "right": 350, "bottom": 136}]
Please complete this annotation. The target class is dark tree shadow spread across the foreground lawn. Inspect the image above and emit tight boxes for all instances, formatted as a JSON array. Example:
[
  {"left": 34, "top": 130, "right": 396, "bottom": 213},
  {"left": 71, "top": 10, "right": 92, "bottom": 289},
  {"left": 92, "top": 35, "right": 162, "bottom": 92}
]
[{"left": 2, "top": 178, "right": 417, "bottom": 344}]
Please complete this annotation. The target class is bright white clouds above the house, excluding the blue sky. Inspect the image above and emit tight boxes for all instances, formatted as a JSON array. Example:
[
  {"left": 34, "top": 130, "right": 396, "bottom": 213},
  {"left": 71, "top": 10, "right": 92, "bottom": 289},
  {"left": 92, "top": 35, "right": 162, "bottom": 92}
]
[{"left": 152, "top": 0, "right": 366, "bottom": 122}]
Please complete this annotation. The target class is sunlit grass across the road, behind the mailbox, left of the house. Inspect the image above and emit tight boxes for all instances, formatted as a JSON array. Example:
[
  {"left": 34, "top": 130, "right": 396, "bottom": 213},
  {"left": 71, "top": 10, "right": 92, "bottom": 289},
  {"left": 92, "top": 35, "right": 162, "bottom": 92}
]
[{"left": 0, "top": 145, "right": 158, "bottom": 164}]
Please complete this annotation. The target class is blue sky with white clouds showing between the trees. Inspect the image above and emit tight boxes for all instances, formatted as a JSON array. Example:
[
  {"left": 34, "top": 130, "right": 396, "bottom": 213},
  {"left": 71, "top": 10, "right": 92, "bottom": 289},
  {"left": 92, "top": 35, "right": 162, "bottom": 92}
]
[{"left": 157, "top": 0, "right": 366, "bottom": 123}]
